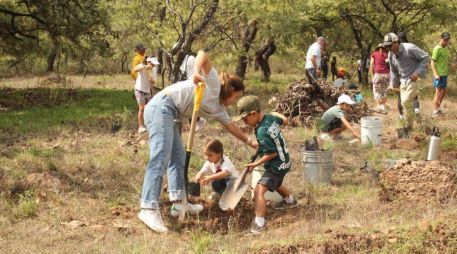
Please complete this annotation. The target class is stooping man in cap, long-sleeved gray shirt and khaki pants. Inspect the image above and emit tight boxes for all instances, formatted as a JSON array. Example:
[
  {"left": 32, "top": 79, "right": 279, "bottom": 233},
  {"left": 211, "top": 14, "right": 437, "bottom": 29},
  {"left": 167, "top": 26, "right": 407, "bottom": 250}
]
[{"left": 384, "top": 33, "right": 429, "bottom": 131}]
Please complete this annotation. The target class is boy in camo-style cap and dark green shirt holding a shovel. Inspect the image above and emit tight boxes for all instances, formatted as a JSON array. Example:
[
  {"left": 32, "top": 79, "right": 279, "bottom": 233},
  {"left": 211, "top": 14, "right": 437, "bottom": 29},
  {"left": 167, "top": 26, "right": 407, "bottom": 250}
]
[{"left": 236, "top": 95, "right": 297, "bottom": 234}]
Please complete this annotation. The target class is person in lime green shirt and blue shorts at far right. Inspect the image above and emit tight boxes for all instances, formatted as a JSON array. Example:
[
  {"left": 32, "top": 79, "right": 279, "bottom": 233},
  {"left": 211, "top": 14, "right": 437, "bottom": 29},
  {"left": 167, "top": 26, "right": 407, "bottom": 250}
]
[{"left": 430, "top": 32, "right": 451, "bottom": 117}]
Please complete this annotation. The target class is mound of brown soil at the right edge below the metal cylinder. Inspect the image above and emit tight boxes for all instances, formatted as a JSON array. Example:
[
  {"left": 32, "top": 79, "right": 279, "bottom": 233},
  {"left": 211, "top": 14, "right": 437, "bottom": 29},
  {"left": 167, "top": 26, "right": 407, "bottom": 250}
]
[{"left": 380, "top": 159, "right": 457, "bottom": 202}]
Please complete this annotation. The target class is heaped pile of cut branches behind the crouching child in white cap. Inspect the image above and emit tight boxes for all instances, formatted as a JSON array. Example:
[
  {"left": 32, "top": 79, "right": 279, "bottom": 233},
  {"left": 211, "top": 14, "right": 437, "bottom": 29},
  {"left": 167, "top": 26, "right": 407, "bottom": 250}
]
[{"left": 274, "top": 79, "right": 372, "bottom": 127}]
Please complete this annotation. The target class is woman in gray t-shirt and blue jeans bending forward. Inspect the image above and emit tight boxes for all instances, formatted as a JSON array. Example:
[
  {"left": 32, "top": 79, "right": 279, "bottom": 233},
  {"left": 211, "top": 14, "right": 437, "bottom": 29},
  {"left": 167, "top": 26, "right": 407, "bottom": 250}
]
[{"left": 138, "top": 51, "right": 258, "bottom": 233}]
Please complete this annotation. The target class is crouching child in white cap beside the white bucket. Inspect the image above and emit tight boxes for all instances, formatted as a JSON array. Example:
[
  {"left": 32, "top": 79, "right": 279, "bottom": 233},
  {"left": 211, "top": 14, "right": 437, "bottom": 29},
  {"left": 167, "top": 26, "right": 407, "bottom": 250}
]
[{"left": 321, "top": 94, "right": 360, "bottom": 139}]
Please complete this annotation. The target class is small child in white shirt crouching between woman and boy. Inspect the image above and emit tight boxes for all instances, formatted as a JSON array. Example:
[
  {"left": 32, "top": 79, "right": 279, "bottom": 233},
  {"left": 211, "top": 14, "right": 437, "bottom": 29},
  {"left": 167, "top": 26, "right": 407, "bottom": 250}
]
[{"left": 194, "top": 139, "right": 239, "bottom": 196}]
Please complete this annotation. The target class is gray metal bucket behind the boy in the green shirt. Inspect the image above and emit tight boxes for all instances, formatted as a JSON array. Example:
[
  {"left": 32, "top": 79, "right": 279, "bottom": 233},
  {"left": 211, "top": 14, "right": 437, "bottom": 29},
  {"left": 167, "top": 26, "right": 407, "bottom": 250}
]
[{"left": 302, "top": 150, "right": 333, "bottom": 184}]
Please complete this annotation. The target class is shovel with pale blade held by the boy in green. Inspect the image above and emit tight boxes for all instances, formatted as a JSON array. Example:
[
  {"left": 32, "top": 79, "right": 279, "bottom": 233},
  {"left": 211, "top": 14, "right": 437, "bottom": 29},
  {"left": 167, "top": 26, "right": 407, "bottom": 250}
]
[{"left": 219, "top": 152, "right": 258, "bottom": 211}]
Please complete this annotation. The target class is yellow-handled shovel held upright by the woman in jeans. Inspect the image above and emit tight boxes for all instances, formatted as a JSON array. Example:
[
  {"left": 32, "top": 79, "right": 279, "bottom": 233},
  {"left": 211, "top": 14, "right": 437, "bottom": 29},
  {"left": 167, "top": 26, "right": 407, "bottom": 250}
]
[{"left": 179, "top": 82, "right": 205, "bottom": 222}]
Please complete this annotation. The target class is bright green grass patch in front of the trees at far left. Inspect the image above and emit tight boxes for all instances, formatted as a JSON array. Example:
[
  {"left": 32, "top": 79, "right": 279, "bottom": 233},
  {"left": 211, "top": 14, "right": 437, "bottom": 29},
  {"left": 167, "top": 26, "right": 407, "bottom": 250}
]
[{"left": 0, "top": 89, "right": 136, "bottom": 133}]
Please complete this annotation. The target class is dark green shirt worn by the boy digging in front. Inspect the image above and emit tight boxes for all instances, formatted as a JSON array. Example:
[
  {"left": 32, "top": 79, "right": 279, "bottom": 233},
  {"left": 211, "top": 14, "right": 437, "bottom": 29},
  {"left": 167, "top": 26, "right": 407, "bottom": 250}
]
[{"left": 255, "top": 114, "right": 291, "bottom": 173}]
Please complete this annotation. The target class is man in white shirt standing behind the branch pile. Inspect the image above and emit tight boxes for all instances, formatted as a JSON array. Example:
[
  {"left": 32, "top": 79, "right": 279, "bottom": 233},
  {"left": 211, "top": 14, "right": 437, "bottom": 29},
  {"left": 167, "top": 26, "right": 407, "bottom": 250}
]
[{"left": 305, "top": 37, "right": 326, "bottom": 85}]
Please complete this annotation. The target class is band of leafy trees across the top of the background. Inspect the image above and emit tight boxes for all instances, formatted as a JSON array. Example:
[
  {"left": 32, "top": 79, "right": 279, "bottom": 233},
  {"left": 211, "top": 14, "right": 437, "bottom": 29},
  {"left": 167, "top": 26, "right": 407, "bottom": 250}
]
[{"left": 0, "top": 0, "right": 457, "bottom": 81}]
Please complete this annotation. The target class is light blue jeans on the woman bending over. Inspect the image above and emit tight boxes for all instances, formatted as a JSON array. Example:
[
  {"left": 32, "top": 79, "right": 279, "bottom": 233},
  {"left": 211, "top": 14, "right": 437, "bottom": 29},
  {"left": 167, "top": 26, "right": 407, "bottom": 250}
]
[{"left": 141, "top": 93, "right": 186, "bottom": 209}]
